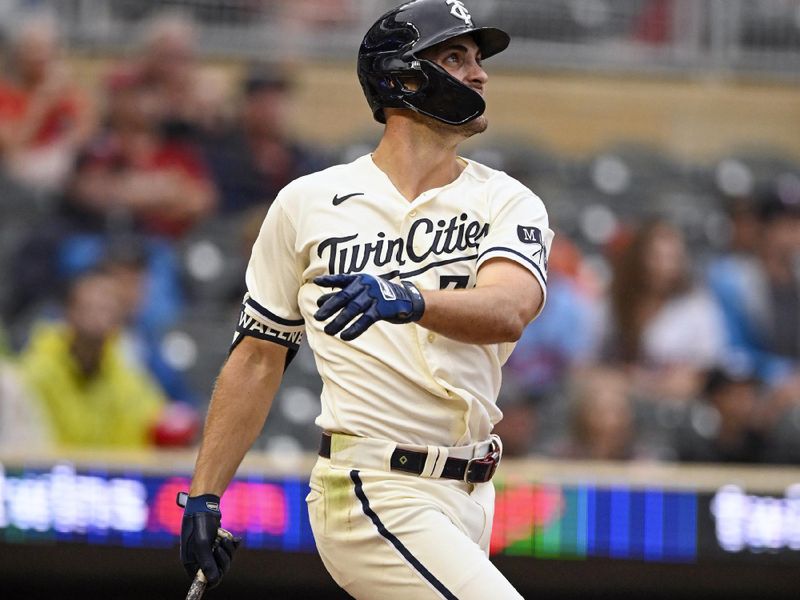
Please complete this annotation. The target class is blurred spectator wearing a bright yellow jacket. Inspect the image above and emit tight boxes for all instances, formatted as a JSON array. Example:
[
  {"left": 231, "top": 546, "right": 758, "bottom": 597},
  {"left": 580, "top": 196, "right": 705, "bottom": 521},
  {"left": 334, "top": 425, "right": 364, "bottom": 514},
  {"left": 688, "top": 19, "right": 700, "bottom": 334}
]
[{"left": 20, "top": 272, "right": 175, "bottom": 447}]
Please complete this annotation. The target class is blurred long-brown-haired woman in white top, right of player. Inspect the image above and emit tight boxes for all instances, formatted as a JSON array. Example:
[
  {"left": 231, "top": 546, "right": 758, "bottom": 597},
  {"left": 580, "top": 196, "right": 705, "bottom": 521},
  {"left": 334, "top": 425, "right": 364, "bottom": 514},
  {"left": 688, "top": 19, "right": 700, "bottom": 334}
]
[{"left": 600, "top": 220, "right": 725, "bottom": 401}]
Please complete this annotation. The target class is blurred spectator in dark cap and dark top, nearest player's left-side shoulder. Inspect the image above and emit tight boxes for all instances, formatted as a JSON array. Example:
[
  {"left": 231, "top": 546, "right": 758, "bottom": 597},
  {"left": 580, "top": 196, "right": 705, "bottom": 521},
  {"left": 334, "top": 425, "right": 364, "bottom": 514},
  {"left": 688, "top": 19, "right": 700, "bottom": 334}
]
[{"left": 204, "top": 64, "right": 325, "bottom": 213}]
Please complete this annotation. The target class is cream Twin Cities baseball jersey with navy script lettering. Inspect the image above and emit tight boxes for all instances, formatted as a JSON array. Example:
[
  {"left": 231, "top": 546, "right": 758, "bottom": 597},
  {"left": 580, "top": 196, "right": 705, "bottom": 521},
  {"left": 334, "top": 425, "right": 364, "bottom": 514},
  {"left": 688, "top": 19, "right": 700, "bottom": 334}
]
[{"left": 234, "top": 155, "right": 553, "bottom": 446}]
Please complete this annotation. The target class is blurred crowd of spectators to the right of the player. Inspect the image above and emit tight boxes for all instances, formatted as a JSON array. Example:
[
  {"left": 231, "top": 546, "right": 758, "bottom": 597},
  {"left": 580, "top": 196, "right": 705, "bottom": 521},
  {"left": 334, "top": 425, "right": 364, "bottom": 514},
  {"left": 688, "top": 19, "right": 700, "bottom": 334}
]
[{"left": 498, "top": 204, "right": 800, "bottom": 463}]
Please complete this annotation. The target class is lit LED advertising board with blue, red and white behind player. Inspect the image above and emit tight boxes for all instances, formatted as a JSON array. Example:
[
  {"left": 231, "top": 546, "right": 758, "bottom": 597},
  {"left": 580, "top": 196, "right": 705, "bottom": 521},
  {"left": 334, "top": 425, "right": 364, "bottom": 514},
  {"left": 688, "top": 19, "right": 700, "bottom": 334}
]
[{"left": 0, "top": 463, "right": 800, "bottom": 564}]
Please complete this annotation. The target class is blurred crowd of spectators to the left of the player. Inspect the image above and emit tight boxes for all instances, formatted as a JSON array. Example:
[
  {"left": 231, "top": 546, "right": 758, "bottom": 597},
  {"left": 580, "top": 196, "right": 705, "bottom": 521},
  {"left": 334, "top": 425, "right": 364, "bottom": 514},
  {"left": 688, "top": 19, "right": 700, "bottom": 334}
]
[{"left": 0, "top": 11, "right": 327, "bottom": 447}]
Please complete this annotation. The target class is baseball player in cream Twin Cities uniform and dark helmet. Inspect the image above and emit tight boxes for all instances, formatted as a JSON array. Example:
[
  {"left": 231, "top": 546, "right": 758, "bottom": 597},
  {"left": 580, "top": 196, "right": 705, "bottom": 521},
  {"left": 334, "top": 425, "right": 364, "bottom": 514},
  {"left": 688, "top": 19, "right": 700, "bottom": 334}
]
[{"left": 181, "top": 0, "right": 553, "bottom": 600}]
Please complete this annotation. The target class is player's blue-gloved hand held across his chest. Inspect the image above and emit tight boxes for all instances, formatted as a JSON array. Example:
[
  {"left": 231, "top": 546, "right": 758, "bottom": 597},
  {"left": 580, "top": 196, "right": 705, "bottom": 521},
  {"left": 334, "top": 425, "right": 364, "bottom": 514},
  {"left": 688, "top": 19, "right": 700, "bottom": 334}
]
[{"left": 314, "top": 273, "right": 425, "bottom": 341}]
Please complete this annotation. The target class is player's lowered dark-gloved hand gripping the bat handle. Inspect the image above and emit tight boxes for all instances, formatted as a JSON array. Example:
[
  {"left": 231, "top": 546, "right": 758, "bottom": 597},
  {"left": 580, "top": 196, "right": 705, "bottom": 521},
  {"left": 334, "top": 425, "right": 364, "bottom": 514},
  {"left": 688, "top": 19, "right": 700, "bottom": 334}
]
[{"left": 181, "top": 494, "right": 241, "bottom": 589}]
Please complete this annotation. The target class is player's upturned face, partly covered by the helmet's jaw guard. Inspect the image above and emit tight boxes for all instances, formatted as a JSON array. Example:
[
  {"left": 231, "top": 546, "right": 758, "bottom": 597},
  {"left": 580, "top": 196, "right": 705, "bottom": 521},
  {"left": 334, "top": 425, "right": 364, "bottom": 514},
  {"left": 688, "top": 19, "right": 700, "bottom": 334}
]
[{"left": 422, "top": 34, "right": 489, "bottom": 136}]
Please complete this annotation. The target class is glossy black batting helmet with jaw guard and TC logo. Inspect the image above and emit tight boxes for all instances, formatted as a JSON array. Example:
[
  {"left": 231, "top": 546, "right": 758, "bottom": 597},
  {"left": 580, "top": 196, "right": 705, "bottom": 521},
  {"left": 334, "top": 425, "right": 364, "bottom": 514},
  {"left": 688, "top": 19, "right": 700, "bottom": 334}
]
[{"left": 358, "top": 0, "right": 511, "bottom": 125}]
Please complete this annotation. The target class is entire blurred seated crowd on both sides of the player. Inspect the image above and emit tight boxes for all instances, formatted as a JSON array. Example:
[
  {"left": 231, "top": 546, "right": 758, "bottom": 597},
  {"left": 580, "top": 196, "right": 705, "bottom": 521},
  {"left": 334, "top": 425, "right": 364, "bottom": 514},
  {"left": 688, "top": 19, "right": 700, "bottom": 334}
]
[{"left": 0, "top": 12, "right": 800, "bottom": 463}]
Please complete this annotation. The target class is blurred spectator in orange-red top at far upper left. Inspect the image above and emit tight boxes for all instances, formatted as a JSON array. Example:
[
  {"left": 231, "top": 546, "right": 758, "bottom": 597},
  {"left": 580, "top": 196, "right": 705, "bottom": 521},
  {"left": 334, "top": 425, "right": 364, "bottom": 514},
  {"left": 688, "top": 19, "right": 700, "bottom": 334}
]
[{"left": 0, "top": 17, "right": 95, "bottom": 192}]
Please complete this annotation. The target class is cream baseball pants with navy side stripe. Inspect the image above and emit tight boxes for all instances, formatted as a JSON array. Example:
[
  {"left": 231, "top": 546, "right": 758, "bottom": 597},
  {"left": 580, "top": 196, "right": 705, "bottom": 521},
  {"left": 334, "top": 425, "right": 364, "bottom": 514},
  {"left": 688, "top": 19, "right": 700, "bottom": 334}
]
[{"left": 306, "top": 437, "right": 522, "bottom": 600}]
